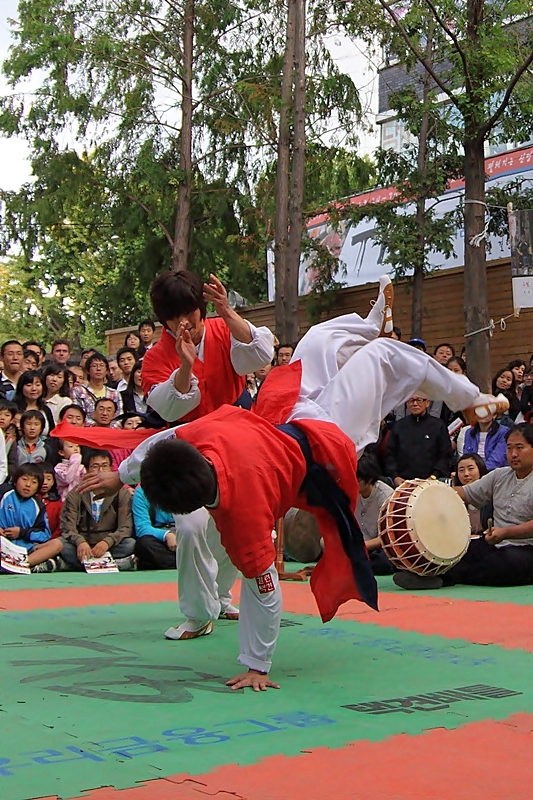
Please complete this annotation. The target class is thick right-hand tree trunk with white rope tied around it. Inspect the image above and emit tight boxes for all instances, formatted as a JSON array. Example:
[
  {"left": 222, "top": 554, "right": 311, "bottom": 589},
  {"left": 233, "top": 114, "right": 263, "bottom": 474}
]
[{"left": 464, "top": 136, "right": 491, "bottom": 392}]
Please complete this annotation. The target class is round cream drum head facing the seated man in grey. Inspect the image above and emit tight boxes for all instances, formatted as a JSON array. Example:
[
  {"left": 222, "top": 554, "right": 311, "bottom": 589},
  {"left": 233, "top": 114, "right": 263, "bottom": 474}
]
[{"left": 409, "top": 483, "right": 470, "bottom": 561}]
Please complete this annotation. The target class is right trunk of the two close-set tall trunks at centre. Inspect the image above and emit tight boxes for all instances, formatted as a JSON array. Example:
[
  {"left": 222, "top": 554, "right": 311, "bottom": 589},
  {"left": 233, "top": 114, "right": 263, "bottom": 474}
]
[{"left": 284, "top": 0, "right": 305, "bottom": 342}]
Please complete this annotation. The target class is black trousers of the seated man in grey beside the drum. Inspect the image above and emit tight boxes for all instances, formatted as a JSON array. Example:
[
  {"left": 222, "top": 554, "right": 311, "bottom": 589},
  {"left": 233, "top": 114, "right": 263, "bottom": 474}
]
[{"left": 442, "top": 538, "right": 533, "bottom": 586}]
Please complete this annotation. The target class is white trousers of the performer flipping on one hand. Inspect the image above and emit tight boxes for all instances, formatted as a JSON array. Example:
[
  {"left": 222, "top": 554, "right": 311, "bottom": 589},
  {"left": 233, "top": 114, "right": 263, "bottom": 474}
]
[{"left": 287, "top": 314, "right": 480, "bottom": 452}]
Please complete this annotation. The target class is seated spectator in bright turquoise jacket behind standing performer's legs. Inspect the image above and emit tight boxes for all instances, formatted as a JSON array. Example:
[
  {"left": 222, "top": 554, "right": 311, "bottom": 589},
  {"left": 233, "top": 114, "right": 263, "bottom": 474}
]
[{"left": 132, "top": 486, "right": 176, "bottom": 569}]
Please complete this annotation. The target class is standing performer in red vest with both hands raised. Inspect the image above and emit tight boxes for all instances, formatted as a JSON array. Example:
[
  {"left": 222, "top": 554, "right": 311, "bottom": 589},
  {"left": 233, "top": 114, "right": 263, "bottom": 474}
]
[{"left": 142, "top": 271, "right": 273, "bottom": 639}]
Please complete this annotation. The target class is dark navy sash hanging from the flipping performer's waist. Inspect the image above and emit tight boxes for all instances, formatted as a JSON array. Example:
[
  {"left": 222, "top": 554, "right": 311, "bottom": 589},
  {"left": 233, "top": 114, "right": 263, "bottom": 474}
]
[{"left": 276, "top": 423, "right": 378, "bottom": 611}]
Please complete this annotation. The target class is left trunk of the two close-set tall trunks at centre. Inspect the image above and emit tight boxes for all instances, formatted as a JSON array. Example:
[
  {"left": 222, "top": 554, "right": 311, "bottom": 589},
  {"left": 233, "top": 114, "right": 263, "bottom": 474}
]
[{"left": 274, "top": 0, "right": 298, "bottom": 342}]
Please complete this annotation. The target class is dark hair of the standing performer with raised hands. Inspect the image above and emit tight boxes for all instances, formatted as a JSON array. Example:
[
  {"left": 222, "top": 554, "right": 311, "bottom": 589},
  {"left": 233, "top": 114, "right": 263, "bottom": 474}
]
[{"left": 150, "top": 270, "right": 207, "bottom": 325}]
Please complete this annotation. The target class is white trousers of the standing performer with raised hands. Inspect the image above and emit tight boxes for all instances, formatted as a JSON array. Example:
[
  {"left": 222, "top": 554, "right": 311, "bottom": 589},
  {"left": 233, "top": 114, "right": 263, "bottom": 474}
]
[{"left": 174, "top": 508, "right": 238, "bottom": 628}]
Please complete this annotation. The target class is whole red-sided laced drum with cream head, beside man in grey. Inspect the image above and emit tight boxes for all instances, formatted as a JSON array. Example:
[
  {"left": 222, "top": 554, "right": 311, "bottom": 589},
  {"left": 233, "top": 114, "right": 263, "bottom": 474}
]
[{"left": 378, "top": 478, "right": 470, "bottom": 575}]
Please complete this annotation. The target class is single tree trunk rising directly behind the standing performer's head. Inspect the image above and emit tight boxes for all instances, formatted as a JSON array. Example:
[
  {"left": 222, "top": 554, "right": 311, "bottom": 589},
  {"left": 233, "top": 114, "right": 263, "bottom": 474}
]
[{"left": 172, "top": 0, "right": 194, "bottom": 270}]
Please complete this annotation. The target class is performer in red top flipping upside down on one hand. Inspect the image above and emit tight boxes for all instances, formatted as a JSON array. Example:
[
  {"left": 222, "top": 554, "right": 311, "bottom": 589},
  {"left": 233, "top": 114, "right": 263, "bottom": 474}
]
[{"left": 58, "top": 279, "right": 505, "bottom": 691}]
